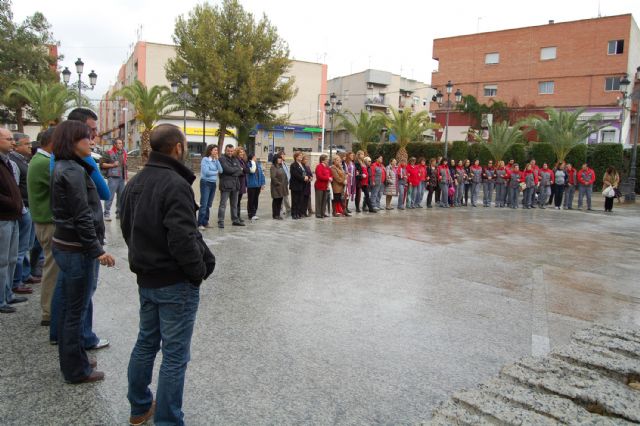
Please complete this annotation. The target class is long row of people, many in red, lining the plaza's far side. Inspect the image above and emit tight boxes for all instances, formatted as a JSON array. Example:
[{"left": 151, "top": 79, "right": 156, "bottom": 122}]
[{"left": 198, "top": 149, "right": 620, "bottom": 225}]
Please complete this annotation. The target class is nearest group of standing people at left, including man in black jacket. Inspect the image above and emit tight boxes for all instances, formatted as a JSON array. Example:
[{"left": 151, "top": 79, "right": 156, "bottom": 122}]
[{"left": 0, "top": 108, "right": 215, "bottom": 425}]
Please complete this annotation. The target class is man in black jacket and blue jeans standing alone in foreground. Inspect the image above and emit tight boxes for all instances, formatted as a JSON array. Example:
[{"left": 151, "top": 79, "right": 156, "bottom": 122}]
[{"left": 120, "top": 124, "right": 215, "bottom": 425}]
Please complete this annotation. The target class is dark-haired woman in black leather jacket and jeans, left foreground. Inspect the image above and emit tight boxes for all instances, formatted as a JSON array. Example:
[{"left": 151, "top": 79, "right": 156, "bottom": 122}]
[{"left": 51, "top": 120, "right": 115, "bottom": 383}]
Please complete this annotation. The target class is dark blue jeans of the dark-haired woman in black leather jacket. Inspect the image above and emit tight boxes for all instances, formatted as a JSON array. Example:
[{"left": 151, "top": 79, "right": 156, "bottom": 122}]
[{"left": 51, "top": 246, "right": 98, "bottom": 382}]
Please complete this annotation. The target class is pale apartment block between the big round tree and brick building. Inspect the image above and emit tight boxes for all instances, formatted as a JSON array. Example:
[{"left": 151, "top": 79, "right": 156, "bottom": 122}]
[{"left": 330, "top": 69, "right": 436, "bottom": 147}]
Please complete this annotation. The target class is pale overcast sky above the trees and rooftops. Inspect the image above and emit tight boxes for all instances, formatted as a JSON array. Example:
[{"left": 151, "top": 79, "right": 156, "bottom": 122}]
[{"left": 13, "top": 0, "right": 640, "bottom": 98}]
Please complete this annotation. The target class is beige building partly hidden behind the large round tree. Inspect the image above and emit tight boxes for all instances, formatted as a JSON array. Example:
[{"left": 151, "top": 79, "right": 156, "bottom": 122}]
[{"left": 98, "top": 41, "right": 327, "bottom": 158}]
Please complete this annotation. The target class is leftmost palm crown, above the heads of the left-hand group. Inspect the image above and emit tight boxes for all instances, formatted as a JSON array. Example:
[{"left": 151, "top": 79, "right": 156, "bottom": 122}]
[{"left": 6, "top": 80, "right": 76, "bottom": 130}]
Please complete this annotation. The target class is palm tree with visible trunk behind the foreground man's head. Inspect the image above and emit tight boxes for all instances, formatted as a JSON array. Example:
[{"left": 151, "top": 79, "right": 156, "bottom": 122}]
[{"left": 113, "top": 80, "right": 176, "bottom": 162}]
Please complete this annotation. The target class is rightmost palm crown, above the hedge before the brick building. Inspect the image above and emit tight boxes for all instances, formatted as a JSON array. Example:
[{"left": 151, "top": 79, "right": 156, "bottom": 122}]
[{"left": 529, "top": 108, "right": 603, "bottom": 162}]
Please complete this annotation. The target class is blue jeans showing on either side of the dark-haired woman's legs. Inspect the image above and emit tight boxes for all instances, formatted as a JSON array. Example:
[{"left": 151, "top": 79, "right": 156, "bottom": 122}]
[{"left": 49, "top": 255, "right": 100, "bottom": 349}]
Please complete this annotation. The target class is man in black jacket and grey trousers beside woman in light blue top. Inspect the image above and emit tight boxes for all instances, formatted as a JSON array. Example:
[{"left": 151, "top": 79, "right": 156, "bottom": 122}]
[{"left": 218, "top": 145, "right": 245, "bottom": 228}]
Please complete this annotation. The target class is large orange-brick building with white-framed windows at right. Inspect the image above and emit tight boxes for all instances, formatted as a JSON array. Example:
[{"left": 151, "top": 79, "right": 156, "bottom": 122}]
[{"left": 431, "top": 14, "right": 640, "bottom": 144}]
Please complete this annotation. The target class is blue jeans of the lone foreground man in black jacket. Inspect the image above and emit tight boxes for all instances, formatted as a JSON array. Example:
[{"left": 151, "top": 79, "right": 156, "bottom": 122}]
[{"left": 127, "top": 283, "right": 200, "bottom": 426}]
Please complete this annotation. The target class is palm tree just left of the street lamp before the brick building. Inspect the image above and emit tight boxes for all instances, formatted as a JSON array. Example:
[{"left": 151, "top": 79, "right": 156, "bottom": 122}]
[{"left": 379, "top": 107, "right": 439, "bottom": 161}]
